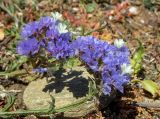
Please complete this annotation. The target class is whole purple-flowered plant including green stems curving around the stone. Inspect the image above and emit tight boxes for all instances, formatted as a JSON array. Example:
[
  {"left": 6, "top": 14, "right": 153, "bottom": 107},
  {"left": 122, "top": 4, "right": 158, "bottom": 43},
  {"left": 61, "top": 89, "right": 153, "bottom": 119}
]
[{"left": 0, "top": 13, "right": 132, "bottom": 116}]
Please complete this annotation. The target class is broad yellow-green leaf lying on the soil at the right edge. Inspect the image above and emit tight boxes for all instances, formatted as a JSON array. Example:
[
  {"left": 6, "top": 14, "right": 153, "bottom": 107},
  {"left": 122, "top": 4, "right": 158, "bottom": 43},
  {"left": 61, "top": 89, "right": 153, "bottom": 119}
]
[{"left": 141, "top": 80, "right": 159, "bottom": 96}]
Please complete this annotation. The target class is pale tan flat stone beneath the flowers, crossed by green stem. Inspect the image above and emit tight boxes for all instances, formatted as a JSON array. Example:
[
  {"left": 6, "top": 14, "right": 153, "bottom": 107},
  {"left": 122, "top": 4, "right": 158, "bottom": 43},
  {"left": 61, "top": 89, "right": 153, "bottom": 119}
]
[{"left": 23, "top": 67, "right": 115, "bottom": 117}]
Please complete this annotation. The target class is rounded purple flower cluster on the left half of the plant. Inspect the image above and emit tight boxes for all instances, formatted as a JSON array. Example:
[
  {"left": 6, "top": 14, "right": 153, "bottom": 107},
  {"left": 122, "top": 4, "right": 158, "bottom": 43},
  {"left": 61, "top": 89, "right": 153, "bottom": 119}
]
[{"left": 17, "top": 17, "right": 73, "bottom": 59}]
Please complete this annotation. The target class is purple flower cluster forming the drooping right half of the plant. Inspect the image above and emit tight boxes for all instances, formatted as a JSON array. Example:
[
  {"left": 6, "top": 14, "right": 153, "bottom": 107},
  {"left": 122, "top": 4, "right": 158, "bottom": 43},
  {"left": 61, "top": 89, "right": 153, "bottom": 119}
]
[{"left": 73, "top": 36, "right": 130, "bottom": 94}]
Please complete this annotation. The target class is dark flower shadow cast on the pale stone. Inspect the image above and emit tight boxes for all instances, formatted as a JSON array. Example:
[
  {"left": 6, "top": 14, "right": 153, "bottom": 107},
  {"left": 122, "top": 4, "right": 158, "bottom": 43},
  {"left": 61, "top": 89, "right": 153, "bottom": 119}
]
[{"left": 43, "top": 70, "right": 89, "bottom": 98}]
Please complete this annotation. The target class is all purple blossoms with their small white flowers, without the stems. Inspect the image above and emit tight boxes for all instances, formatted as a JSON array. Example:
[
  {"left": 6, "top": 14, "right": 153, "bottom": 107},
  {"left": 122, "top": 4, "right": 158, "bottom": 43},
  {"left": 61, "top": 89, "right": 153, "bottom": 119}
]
[{"left": 17, "top": 13, "right": 132, "bottom": 95}]
